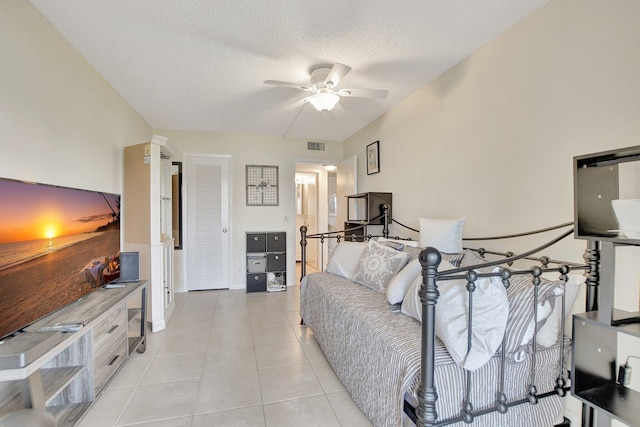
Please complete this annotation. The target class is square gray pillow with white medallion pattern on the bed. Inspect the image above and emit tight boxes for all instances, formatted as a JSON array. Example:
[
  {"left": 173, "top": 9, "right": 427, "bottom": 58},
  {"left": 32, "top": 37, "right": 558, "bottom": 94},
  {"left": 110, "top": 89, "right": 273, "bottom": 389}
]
[{"left": 351, "top": 240, "right": 409, "bottom": 292}]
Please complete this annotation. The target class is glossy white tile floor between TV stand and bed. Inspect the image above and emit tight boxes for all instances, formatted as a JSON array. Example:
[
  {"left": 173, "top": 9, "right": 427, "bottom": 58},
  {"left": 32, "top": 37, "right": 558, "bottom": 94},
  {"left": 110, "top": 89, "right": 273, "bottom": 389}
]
[{"left": 79, "top": 278, "right": 380, "bottom": 427}]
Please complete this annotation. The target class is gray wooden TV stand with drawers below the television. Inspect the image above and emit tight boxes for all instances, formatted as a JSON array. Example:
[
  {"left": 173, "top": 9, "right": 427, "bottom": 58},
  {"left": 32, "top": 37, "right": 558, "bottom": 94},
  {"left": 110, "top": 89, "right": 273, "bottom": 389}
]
[{"left": 0, "top": 281, "right": 147, "bottom": 426}]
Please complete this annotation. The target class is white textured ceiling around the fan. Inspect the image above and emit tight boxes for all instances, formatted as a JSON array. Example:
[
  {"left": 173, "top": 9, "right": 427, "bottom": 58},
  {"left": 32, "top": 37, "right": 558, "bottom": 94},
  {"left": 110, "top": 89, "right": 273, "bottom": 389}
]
[{"left": 32, "top": 0, "right": 548, "bottom": 141}]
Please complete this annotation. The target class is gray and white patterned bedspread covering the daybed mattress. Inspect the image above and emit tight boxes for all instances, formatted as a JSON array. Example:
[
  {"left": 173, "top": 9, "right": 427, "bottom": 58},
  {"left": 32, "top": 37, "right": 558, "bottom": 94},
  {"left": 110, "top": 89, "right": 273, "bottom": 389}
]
[{"left": 300, "top": 273, "right": 562, "bottom": 427}]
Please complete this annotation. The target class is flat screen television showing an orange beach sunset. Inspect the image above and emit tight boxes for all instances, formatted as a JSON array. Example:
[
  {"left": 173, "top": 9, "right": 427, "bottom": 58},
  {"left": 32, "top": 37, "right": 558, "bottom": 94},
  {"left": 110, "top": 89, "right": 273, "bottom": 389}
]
[{"left": 0, "top": 178, "right": 120, "bottom": 338}]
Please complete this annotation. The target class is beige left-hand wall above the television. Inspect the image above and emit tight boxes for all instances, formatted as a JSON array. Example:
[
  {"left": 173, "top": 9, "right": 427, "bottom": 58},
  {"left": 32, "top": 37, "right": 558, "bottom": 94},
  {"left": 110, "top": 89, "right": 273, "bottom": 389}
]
[{"left": 0, "top": 0, "right": 151, "bottom": 194}]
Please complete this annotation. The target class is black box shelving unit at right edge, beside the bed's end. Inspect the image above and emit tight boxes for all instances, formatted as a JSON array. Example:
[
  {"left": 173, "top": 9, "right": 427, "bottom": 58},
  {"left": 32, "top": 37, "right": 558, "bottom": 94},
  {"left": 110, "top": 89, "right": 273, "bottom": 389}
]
[{"left": 571, "top": 146, "right": 640, "bottom": 426}]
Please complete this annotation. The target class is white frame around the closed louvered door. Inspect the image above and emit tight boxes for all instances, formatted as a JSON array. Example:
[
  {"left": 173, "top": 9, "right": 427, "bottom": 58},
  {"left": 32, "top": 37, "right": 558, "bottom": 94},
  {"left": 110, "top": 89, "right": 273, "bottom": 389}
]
[{"left": 182, "top": 153, "right": 233, "bottom": 292}]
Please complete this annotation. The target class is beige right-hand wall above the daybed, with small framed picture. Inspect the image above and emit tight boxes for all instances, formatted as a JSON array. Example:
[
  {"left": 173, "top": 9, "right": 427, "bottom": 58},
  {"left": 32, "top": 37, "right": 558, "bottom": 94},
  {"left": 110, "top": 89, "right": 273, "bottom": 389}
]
[{"left": 344, "top": 0, "right": 640, "bottom": 422}]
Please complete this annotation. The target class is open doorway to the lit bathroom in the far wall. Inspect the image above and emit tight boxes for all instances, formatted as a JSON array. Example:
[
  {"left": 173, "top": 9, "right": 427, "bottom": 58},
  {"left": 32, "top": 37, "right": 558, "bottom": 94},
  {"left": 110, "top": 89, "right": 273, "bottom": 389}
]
[{"left": 295, "top": 163, "right": 336, "bottom": 272}]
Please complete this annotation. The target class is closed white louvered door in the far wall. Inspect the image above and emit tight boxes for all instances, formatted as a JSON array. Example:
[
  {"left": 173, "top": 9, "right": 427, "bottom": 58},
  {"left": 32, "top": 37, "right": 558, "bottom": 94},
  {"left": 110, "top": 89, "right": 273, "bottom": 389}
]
[{"left": 186, "top": 156, "right": 231, "bottom": 291}]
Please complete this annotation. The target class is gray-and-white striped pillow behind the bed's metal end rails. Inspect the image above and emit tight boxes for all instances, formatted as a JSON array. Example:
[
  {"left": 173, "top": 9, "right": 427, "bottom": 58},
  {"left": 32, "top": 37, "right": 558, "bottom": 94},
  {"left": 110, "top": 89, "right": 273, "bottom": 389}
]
[{"left": 506, "top": 275, "right": 564, "bottom": 362}]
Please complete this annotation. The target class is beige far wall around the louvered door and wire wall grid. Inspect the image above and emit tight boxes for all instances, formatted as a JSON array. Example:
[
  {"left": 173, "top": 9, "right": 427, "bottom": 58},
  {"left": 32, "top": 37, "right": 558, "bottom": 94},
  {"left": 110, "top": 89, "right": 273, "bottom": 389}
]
[{"left": 155, "top": 130, "right": 342, "bottom": 291}]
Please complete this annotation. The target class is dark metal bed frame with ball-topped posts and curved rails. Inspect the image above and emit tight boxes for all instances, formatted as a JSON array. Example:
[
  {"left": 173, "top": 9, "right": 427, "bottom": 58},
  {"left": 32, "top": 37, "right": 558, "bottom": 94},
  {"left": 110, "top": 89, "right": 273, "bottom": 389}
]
[{"left": 300, "top": 205, "right": 600, "bottom": 427}]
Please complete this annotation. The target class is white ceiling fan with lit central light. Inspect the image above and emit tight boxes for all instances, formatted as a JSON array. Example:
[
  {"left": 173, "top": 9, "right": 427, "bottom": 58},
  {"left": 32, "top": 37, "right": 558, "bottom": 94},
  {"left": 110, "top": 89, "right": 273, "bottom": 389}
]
[{"left": 264, "top": 63, "right": 389, "bottom": 113}]
